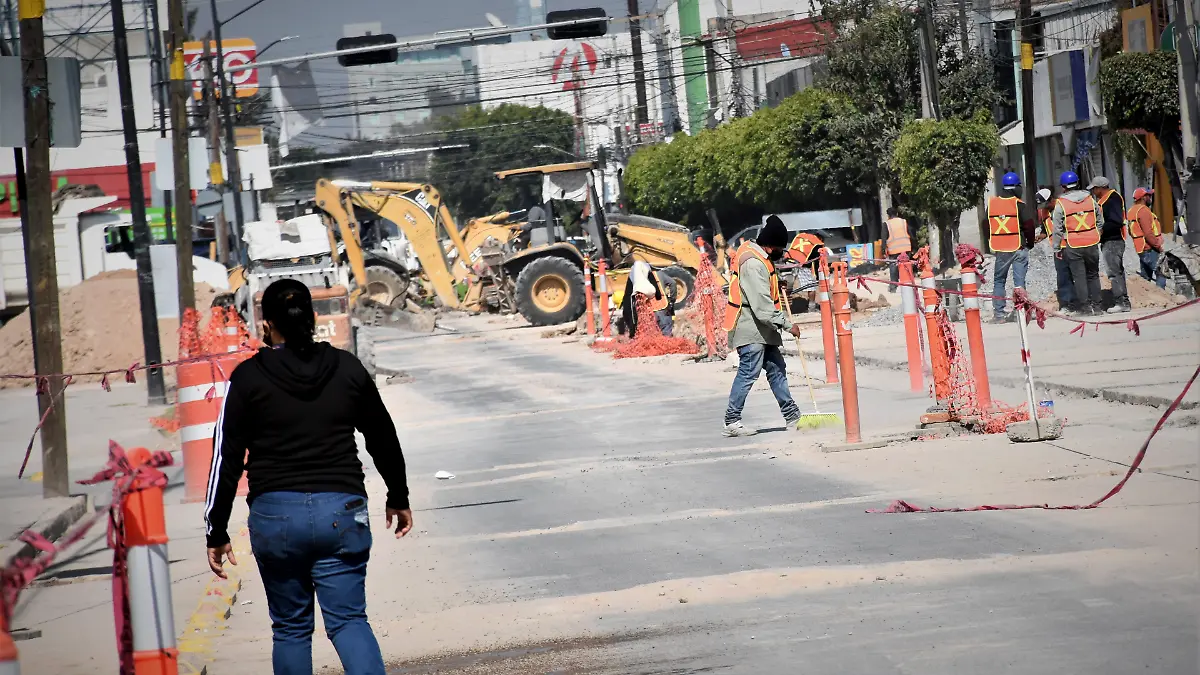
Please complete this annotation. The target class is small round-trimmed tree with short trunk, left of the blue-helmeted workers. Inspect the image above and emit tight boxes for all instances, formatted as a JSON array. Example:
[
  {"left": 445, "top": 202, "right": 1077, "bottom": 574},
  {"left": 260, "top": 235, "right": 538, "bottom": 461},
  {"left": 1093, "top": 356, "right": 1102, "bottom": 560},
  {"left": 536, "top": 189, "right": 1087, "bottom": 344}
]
[{"left": 892, "top": 113, "right": 1000, "bottom": 264}]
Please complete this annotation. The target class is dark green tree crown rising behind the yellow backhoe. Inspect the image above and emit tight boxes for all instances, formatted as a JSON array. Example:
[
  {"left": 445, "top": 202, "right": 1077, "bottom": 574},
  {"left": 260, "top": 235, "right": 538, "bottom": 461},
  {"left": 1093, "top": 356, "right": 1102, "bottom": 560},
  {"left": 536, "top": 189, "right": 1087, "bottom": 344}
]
[{"left": 430, "top": 103, "right": 575, "bottom": 220}]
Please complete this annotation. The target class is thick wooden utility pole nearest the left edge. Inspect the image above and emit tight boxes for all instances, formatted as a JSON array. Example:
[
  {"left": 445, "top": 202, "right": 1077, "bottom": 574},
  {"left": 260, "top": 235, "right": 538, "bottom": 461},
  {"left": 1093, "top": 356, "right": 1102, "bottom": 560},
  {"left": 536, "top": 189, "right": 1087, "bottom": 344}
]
[{"left": 17, "top": 2, "right": 71, "bottom": 498}]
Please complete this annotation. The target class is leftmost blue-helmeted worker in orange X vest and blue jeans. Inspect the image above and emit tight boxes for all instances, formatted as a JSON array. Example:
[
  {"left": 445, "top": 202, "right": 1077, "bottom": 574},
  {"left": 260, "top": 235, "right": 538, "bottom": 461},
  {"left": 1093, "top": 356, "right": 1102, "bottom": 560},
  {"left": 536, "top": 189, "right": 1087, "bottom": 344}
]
[{"left": 988, "top": 172, "right": 1038, "bottom": 323}]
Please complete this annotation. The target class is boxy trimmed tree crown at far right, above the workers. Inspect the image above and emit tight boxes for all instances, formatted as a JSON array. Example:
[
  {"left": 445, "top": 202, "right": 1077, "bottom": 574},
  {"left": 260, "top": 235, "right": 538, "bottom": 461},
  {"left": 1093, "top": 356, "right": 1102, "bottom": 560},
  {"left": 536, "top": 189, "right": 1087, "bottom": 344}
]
[{"left": 1100, "top": 52, "right": 1180, "bottom": 136}]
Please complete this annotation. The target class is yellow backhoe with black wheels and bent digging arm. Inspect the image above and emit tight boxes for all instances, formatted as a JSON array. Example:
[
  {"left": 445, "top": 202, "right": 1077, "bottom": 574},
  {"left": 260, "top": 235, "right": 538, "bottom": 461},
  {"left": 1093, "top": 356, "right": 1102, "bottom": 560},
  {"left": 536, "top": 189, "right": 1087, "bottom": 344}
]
[{"left": 314, "top": 162, "right": 702, "bottom": 325}]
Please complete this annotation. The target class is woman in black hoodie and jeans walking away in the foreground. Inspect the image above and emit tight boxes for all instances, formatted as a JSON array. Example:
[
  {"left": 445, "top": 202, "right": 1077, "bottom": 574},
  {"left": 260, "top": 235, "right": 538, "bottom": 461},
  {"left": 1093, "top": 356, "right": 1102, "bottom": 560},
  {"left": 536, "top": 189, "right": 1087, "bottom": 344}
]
[{"left": 204, "top": 279, "right": 413, "bottom": 675}]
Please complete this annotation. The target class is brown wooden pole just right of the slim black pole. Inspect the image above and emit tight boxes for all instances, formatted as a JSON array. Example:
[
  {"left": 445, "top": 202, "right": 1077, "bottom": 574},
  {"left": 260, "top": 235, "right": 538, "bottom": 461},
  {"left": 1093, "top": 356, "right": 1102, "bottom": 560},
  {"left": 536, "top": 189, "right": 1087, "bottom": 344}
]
[{"left": 167, "top": 0, "right": 196, "bottom": 307}]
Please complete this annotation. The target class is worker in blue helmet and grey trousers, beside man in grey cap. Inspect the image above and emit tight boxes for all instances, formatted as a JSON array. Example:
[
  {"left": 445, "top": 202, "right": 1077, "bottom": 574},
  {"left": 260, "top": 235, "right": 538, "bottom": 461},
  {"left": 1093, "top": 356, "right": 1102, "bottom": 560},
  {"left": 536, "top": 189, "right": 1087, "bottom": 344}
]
[{"left": 1050, "top": 171, "right": 1104, "bottom": 316}]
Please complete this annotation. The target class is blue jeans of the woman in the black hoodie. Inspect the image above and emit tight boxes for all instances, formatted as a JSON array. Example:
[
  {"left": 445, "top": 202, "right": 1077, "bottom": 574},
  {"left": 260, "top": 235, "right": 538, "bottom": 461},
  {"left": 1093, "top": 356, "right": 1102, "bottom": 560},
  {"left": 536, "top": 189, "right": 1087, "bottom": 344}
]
[{"left": 248, "top": 492, "right": 384, "bottom": 675}]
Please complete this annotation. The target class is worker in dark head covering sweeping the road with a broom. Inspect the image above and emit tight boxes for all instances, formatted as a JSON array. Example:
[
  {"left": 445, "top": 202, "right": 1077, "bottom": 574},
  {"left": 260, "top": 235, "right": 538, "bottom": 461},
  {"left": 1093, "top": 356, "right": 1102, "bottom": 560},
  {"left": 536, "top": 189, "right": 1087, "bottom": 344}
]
[{"left": 722, "top": 215, "right": 800, "bottom": 436}]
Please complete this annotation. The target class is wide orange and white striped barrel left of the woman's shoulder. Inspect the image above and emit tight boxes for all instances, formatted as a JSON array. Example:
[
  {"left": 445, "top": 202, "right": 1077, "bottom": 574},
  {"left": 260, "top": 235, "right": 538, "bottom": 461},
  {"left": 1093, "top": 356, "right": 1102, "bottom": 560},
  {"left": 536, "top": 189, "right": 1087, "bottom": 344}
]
[{"left": 175, "top": 357, "right": 248, "bottom": 502}]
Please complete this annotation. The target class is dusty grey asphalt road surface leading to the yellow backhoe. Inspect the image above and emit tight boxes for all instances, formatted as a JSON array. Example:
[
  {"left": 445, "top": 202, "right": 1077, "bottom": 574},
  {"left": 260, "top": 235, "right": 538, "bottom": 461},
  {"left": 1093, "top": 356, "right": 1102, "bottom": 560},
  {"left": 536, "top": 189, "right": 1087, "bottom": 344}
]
[{"left": 362, "top": 327, "right": 1200, "bottom": 675}]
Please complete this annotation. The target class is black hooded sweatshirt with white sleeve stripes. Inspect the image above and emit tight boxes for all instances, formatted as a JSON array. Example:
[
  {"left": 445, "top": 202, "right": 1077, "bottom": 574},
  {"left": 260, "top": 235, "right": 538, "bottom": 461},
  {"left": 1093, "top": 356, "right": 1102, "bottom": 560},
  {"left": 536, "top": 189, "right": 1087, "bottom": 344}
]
[{"left": 204, "top": 342, "right": 408, "bottom": 548}]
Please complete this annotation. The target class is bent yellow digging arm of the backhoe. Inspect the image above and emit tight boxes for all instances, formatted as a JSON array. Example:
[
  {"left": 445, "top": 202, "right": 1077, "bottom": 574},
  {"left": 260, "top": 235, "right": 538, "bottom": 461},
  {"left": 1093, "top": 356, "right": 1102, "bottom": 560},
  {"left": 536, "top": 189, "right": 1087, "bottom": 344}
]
[{"left": 317, "top": 179, "right": 472, "bottom": 309}]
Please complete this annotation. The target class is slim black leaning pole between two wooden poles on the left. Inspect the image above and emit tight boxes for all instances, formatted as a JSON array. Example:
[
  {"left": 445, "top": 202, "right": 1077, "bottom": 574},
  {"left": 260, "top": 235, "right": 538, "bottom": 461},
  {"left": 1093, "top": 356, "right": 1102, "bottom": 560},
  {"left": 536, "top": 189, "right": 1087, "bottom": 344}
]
[{"left": 113, "top": 0, "right": 167, "bottom": 405}]
